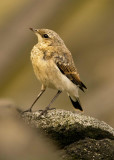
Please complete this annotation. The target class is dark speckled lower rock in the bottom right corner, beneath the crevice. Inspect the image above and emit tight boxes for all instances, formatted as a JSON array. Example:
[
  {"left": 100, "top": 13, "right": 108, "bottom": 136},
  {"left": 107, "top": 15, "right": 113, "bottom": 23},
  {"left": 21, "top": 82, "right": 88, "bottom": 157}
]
[{"left": 62, "top": 138, "right": 114, "bottom": 160}]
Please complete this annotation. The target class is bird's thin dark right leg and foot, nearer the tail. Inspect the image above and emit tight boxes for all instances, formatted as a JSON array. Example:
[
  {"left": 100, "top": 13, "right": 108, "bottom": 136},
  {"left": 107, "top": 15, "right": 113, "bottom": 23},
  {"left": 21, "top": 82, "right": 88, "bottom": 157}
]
[{"left": 39, "top": 91, "right": 62, "bottom": 117}]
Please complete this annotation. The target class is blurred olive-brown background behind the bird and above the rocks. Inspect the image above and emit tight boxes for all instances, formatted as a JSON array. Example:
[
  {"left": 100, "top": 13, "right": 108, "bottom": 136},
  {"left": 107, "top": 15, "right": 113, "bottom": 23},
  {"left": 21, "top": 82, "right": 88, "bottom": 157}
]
[{"left": 0, "top": 0, "right": 114, "bottom": 127}]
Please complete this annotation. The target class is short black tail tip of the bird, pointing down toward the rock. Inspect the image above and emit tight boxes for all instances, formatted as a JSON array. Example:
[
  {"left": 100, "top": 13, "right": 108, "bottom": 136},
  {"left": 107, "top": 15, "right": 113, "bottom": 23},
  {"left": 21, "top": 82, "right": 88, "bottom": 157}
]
[{"left": 69, "top": 96, "right": 83, "bottom": 111}]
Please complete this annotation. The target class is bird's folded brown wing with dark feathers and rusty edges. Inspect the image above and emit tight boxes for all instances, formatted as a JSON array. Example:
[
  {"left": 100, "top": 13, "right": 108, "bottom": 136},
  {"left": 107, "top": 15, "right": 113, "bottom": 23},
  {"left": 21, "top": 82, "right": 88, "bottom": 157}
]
[{"left": 56, "top": 54, "right": 87, "bottom": 91}]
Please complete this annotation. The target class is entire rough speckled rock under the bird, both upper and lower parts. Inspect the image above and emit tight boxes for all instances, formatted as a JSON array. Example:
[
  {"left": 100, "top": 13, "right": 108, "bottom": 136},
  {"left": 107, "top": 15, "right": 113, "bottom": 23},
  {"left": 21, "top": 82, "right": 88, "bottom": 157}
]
[{"left": 22, "top": 110, "right": 114, "bottom": 160}]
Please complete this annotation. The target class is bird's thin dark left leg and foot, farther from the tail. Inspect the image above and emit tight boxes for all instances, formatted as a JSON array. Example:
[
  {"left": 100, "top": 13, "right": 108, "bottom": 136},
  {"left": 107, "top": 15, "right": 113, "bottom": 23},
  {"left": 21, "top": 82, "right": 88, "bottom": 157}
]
[{"left": 22, "top": 85, "right": 46, "bottom": 113}]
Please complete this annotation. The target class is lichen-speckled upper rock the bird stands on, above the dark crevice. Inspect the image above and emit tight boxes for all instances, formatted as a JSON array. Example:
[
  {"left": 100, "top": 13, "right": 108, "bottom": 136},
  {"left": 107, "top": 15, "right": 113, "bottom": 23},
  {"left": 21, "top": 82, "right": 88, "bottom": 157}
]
[{"left": 22, "top": 110, "right": 114, "bottom": 147}]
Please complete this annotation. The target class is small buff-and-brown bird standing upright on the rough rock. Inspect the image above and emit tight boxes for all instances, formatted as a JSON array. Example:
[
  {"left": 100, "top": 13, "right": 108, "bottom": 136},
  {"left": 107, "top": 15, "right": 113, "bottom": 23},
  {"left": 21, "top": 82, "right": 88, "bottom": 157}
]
[{"left": 24, "top": 28, "right": 87, "bottom": 114}]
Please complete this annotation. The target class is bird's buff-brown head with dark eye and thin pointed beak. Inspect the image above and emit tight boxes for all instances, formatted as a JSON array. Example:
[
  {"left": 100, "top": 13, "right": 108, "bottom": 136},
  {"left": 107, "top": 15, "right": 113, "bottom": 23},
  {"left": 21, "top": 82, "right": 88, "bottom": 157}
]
[{"left": 30, "top": 28, "right": 64, "bottom": 46}]
